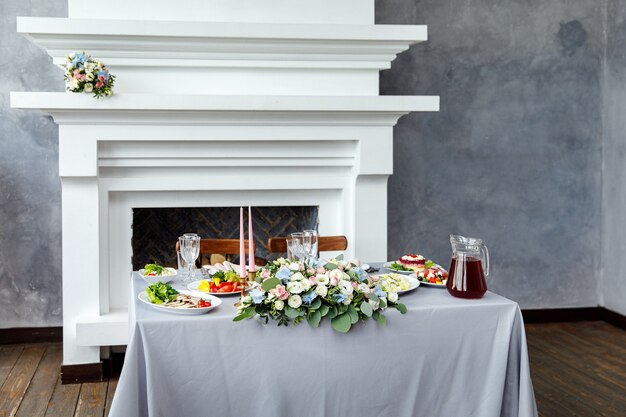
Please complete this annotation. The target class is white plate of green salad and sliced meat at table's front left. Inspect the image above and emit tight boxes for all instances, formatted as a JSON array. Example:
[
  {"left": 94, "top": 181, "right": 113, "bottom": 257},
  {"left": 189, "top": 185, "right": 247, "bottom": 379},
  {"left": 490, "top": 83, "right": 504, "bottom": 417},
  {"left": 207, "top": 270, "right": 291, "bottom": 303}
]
[{"left": 137, "top": 282, "right": 222, "bottom": 316}]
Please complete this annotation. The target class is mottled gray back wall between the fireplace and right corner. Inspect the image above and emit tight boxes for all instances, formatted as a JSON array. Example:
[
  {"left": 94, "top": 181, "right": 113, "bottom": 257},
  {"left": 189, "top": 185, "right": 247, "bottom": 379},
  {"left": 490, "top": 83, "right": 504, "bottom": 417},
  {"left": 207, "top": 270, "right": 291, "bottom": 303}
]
[{"left": 376, "top": 0, "right": 604, "bottom": 308}]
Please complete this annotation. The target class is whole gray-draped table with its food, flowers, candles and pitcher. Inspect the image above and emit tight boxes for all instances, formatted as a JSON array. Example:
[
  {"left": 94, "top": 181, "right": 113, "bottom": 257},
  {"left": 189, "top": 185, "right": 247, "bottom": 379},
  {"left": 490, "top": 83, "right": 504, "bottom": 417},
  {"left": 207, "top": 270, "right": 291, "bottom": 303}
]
[{"left": 110, "top": 209, "right": 537, "bottom": 417}]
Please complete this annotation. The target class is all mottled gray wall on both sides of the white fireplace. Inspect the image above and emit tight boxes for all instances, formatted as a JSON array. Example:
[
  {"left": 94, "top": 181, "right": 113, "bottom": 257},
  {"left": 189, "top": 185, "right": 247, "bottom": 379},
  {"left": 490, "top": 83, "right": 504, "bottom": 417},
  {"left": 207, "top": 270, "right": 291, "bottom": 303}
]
[{"left": 0, "top": 0, "right": 626, "bottom": 327}]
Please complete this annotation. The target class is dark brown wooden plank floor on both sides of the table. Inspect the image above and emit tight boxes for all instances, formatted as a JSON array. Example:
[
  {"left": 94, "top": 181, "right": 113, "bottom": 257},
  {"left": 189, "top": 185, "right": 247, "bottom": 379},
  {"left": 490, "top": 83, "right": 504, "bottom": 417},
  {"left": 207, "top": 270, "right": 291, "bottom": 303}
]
[{"left": 0, "top": 321, "right": 626, "bottom": 417}]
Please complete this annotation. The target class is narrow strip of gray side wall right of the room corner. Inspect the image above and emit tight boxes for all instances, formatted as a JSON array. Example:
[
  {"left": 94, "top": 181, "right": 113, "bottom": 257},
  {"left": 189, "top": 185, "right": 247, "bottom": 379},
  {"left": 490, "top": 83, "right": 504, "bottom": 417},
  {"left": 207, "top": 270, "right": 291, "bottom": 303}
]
[{"left": 601, "top": 0, "right": 626, "bottom": 315}]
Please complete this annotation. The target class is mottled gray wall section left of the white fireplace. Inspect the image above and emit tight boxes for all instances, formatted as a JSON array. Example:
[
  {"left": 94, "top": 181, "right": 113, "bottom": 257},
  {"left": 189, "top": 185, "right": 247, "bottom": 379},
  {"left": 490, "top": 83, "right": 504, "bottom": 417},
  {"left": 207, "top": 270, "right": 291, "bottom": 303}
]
[{"left": 0, "top": 0, "right": 67, "bottom": 328}]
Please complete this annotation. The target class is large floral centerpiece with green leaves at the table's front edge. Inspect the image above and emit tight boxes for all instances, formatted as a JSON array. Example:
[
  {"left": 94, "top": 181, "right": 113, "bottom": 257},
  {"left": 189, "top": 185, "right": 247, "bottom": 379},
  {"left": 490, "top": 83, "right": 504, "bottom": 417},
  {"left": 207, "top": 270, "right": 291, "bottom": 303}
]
[{"left": 234, "top": 257, "right": 406, "bottom": 333}]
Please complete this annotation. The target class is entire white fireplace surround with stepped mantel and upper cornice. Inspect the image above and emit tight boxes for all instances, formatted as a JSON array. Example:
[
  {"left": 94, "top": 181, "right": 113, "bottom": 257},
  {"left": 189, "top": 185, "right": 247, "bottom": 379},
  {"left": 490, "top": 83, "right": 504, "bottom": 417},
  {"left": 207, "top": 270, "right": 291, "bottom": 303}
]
[{"left": 11, "top": 0, "right": 439, "bottom": 365}]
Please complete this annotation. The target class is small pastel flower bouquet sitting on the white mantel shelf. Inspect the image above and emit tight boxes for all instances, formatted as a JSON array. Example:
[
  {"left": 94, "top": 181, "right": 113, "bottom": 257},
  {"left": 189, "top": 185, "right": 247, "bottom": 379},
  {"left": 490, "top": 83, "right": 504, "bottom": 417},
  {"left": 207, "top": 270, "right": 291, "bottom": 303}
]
[{"left": 65, "top": 52, "right": 115, "bottom": 98}]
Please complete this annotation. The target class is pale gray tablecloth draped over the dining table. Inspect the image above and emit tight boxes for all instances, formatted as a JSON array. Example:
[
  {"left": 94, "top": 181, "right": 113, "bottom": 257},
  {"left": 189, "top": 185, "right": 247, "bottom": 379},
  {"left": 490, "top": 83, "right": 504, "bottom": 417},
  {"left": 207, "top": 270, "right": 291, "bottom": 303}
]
[{"left": 110, "top": 266, "right": 537, "bottom": 417}]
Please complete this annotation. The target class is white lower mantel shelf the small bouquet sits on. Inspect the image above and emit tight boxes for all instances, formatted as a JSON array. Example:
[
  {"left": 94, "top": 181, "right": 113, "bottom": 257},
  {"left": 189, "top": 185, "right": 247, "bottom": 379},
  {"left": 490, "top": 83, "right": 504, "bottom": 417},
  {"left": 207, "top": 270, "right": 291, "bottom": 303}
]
[{"left": 11, "top": 92, "right": 439, "bottom": 125}]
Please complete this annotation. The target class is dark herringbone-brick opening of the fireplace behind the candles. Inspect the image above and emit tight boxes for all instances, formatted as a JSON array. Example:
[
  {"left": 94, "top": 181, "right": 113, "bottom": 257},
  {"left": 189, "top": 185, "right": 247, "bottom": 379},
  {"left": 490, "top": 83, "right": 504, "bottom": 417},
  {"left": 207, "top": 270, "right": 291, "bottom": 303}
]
[{"left": 131, "top": 206, "right": 319, "bottom": 270}]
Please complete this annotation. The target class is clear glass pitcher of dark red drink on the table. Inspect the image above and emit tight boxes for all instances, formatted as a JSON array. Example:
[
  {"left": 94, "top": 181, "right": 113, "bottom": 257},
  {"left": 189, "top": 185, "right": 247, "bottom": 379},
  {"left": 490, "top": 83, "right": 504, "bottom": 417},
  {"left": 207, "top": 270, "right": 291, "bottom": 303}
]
[{"left": 446, "top": 235, "right": 489, "bottom": 298}]
